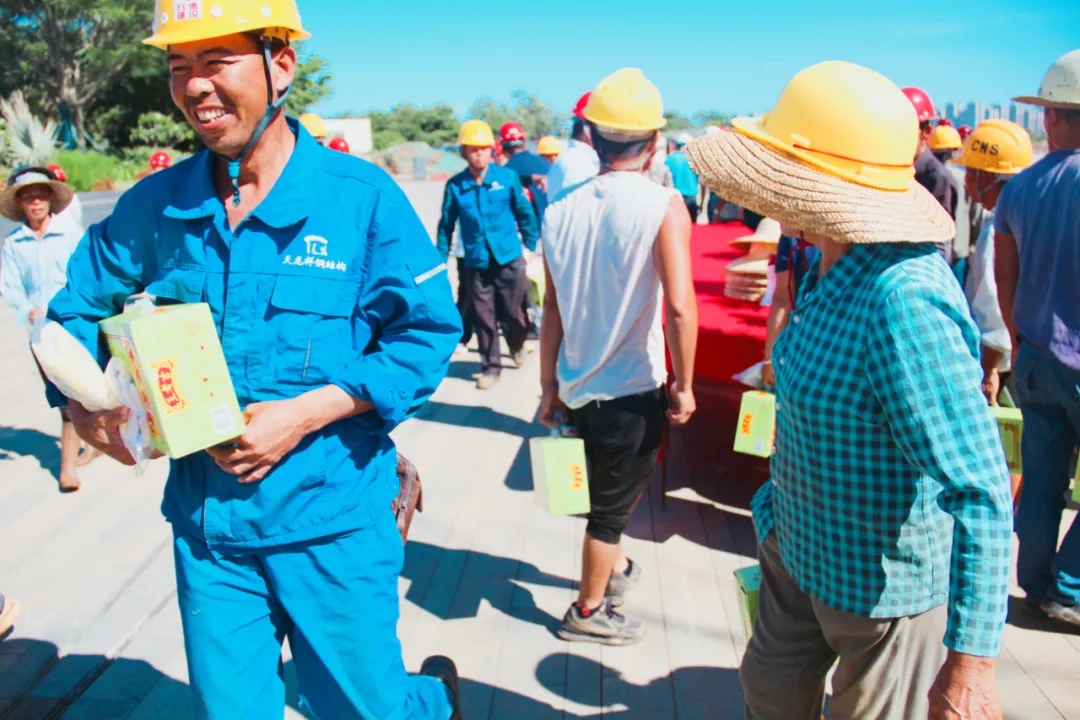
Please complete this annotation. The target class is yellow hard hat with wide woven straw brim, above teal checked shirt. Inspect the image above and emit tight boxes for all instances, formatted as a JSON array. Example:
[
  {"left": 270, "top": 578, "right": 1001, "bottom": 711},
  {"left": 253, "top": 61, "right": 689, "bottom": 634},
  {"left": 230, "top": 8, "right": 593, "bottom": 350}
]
[{"left": 687, "top": 60, "right": 956, "bottom": 243}]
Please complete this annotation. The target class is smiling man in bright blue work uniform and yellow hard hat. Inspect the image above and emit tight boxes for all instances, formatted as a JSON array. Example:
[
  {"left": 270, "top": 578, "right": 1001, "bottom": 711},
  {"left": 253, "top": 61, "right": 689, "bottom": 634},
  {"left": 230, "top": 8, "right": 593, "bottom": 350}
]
[{"left": 42, "top": 0, "right": 461, "bottom": 720}]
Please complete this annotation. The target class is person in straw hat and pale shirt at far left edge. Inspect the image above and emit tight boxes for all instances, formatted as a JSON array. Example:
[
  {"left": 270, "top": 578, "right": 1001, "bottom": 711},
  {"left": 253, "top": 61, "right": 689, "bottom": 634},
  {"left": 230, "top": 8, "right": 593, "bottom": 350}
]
[{"left": 0, "top": 167, "right": 96, "bottom": 492}]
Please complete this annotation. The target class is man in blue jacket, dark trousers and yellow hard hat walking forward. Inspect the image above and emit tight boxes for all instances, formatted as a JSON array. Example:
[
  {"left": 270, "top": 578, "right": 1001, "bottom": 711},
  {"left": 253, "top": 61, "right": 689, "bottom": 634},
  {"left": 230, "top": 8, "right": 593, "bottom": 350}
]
[{"left": 437, "top": 120, "right": 540, "bottom": 390}]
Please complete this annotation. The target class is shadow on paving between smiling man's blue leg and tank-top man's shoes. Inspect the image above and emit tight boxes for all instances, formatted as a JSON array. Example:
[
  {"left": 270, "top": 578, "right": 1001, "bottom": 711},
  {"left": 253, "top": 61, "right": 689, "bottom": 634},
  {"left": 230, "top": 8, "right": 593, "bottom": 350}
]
[{"left": 402, "top": 541, "right": 577, "bottom": 633}]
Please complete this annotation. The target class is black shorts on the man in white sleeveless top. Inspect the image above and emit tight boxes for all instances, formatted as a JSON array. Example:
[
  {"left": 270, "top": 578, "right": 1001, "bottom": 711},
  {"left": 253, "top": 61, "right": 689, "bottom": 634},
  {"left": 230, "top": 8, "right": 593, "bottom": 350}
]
[{"left": 570, "top": 388, "right": 667, "bottom": 545}]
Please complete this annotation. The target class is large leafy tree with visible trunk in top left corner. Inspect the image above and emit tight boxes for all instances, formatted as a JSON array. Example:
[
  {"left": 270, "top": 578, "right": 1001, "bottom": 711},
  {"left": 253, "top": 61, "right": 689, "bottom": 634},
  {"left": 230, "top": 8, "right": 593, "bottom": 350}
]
[{"left": 0, "top": 0, "right": 153, "bottom": 147}]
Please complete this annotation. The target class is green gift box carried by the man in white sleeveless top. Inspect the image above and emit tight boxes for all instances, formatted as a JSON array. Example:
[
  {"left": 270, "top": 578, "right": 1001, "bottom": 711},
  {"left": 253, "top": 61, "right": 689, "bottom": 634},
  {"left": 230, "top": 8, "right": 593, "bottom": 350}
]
[{"left": 529, "top": 437, "right": 591, "bottom": 515}]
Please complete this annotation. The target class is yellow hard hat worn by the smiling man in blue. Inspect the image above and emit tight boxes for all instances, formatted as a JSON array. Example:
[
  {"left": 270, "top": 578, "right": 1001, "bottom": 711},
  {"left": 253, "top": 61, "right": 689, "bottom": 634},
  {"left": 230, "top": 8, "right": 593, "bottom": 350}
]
[{"left": 143, "top": 0, "right": 311, "bottom": 50}]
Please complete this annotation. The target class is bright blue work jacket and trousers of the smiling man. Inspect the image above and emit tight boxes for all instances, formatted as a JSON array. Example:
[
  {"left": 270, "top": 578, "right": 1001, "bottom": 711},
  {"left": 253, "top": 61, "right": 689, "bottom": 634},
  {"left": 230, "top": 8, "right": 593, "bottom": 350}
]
[{"left": 49, "top": 119, "right": 461, "bottom": 720}]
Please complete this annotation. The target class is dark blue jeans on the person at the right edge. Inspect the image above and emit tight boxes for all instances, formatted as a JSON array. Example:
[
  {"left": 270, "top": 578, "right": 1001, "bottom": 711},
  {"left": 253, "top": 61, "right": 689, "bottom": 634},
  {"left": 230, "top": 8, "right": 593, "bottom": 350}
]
[{"left": 1013, "top": 341, "right": 1080, "bottom": 606}]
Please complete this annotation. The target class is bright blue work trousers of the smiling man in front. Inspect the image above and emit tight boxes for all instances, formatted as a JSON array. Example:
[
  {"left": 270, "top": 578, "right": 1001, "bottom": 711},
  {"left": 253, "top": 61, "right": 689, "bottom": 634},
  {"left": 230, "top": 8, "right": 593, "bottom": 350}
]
[{"left": 174, "top": 510, "right": 451, "bottom": 720}]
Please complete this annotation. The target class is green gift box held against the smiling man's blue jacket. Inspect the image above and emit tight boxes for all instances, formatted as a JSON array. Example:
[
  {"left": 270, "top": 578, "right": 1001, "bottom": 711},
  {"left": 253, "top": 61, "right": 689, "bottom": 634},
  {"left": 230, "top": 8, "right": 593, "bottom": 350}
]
[{"left": 99, "top": 303, "right": 244, "bottom": 458}]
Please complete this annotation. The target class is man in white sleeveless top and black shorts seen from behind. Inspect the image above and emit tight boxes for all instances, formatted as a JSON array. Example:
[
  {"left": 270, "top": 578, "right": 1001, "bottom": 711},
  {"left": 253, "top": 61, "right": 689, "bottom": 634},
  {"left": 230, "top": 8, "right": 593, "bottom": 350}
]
[{"left": 540, "top": 69, "right": 698, "bottom": 646}]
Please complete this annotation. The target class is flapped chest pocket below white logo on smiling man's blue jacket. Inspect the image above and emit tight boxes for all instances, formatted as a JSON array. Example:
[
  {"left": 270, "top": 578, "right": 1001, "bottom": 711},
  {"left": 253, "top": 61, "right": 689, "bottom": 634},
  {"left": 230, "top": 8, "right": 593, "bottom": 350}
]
[{"left": 252, "top": 275, "right": 360, "bottom": 389}]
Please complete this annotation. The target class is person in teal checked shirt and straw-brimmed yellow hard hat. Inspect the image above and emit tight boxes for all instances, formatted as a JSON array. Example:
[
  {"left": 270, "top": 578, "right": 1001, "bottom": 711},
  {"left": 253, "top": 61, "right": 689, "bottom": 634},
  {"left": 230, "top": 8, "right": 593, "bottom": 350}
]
[{"left": 687, "top": 62, "right": 1012, "bottom": 720}]
